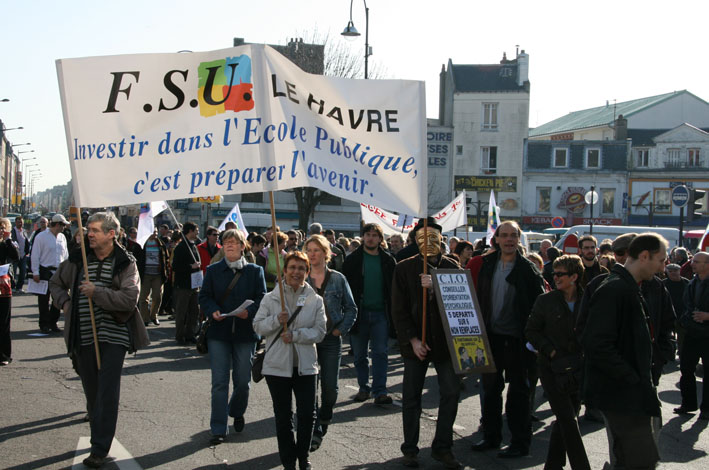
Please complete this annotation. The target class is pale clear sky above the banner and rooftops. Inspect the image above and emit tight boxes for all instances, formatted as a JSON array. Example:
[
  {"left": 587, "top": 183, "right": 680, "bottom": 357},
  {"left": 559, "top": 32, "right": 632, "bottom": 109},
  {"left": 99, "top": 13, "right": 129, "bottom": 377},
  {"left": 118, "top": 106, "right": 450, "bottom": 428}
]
[{"left": 0, "top": 0, "right": 709, "bottom": 191}]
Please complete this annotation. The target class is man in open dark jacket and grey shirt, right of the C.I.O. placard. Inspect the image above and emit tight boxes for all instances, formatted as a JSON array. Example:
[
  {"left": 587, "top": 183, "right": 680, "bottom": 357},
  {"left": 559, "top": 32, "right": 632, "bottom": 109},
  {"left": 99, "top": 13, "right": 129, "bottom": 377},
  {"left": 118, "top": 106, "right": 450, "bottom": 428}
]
[{"left": 473, "top": 221, "right": 544, "bottom": 458}]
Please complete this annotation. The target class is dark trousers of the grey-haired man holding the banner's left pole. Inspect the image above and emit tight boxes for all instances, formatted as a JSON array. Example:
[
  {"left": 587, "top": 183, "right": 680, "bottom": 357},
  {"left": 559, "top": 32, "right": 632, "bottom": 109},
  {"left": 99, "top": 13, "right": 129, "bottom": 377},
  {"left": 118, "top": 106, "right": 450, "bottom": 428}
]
[{"left": 76, "top": 343, "right": 126, "bottom": 457}]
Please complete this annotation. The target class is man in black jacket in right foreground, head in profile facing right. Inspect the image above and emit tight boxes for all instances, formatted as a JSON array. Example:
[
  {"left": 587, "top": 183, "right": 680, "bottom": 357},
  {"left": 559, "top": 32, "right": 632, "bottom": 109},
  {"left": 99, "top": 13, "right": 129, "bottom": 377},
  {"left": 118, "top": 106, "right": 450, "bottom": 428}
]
[{"left": 581, "top": 233, "right": 667, "bottom": 468}]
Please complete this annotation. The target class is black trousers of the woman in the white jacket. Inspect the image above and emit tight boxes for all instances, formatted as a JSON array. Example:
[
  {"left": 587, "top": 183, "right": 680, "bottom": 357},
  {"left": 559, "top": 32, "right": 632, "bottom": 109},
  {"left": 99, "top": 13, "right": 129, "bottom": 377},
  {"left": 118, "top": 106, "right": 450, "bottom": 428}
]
[{"left": 265, "top": 368, "right": 317, "bottom": 468}]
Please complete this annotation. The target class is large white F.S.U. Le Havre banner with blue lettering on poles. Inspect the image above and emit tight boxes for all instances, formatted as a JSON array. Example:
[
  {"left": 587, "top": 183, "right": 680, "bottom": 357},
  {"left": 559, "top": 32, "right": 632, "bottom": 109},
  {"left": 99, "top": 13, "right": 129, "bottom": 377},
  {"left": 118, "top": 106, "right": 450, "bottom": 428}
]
[{"left": 57, "top": 44, "right": 427, "bottom": 216}]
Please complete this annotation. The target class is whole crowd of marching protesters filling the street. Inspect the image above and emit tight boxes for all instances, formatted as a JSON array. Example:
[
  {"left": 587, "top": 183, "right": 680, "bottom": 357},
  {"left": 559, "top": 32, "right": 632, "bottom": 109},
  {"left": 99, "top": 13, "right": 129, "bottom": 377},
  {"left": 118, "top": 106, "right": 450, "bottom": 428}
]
[{"left": 0, "top": 212, "right": 709, "bottom": 470}]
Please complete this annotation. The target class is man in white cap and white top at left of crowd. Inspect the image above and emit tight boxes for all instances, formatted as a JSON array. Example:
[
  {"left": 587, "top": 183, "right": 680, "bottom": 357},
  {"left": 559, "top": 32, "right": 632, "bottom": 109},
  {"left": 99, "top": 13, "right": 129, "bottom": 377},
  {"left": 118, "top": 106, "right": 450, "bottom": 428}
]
[{"left": 30, "top": 214, "right": 69, "bottom": 333}]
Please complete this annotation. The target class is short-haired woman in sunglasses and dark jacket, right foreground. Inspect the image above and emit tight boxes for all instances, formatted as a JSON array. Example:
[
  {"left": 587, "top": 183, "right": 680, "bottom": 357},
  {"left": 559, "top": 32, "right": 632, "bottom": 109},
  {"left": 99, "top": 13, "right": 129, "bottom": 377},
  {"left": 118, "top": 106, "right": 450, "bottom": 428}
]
[{"left": 525, "top": 255, "right": 591, "bottom": 470}]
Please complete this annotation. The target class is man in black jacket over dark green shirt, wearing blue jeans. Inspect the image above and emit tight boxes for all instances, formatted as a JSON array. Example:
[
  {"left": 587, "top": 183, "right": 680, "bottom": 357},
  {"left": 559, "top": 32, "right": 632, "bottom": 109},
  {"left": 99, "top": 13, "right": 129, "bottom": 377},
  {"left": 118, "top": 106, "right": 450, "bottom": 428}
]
[{"left": 342, "top": 223, "right": 396, "bottom": 405}]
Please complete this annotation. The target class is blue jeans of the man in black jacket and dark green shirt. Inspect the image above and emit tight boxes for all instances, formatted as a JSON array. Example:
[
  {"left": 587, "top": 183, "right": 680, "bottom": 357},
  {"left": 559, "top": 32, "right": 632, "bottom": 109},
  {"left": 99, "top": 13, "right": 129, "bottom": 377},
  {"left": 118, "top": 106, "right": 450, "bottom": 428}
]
[{"left": 351, "top": 310, "right": 389, "bottom": 397}]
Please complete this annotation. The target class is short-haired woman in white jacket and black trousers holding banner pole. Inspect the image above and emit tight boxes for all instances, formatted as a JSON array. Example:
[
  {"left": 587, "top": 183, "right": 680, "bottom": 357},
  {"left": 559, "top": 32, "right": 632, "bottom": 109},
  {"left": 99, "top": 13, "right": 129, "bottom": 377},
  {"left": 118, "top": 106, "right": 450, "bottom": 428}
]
[{"left": 253, "top": 251, "right": 326, "bottom": 470}]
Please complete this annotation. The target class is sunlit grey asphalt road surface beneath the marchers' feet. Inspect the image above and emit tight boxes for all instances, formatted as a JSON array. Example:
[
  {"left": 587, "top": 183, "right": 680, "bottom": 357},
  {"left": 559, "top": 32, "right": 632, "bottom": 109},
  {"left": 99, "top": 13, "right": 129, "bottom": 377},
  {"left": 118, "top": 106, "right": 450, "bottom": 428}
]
[{"left": 0, "top": 295, "right": 709, "bottom": 470}]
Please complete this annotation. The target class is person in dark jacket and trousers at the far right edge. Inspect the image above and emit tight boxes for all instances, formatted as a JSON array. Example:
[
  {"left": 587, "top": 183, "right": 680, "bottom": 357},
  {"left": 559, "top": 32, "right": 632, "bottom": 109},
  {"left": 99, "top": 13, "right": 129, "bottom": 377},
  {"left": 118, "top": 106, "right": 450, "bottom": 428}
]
[{"left": 674, "top": 251, "right": 709, "bottom": 420}]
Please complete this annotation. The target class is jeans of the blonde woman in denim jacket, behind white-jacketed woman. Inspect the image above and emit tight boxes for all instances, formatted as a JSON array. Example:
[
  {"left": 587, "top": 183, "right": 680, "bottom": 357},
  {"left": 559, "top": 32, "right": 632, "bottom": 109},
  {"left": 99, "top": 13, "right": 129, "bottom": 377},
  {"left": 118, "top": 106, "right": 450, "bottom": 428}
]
[{"left": 315, "top": 334, "right": 342, "bottom": 435}]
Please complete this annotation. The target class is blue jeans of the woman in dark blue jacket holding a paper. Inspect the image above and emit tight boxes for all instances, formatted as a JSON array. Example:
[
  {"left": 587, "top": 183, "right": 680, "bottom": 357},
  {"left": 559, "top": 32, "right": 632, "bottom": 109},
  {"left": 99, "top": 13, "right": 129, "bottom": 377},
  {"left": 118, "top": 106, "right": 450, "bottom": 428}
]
[{"left": 207, "top": 339, "right": 256, "bottom": 436}]
